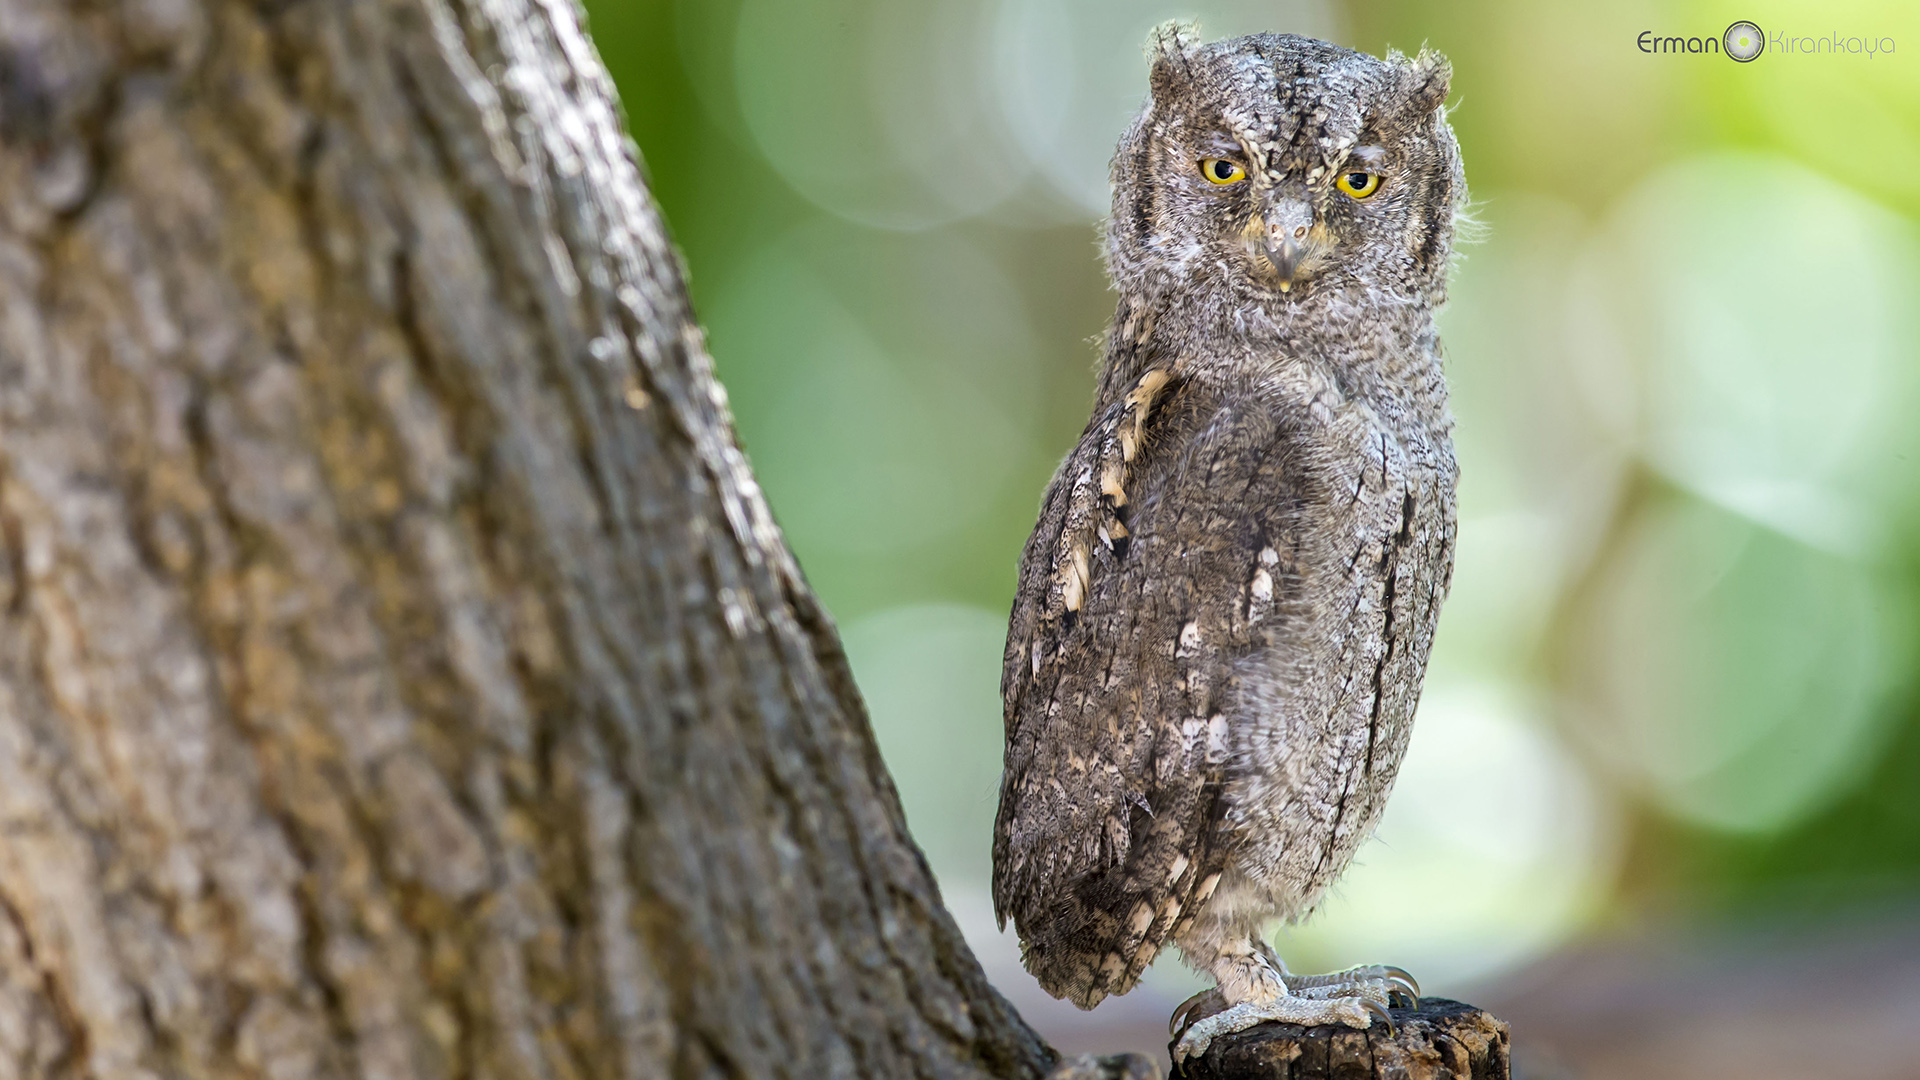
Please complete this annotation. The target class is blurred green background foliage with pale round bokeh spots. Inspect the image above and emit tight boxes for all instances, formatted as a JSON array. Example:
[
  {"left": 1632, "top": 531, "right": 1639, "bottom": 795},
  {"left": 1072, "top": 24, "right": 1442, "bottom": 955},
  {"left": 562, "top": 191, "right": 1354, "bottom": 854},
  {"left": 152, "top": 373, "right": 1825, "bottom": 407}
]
[{"left": 588, "top": 0, "right": 1920, "bottom": 970}]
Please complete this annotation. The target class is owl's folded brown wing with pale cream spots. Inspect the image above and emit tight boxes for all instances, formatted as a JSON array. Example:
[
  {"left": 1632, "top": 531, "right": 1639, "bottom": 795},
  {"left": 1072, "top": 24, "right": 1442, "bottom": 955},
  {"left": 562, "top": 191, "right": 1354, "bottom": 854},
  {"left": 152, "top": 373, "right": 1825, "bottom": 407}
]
[{"left": 993, "top": 369, "right": 1302, "bottom": 1009}]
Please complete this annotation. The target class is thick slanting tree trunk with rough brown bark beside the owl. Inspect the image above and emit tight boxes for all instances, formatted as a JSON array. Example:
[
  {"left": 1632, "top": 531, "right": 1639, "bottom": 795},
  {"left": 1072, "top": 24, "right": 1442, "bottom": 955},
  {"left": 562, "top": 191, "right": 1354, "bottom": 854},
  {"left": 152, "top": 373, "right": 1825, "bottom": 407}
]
[{"left": 0, "top": 0, "right": 1052, "bottom": 1080}]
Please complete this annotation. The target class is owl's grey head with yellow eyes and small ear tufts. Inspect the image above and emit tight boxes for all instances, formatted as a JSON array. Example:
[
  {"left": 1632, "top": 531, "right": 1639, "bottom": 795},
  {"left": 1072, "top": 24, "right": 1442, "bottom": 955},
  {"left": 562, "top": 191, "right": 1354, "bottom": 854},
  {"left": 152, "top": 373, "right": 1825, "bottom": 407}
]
[{"left": 1106, "top": 23, "right": 1467, "bottom": 313}]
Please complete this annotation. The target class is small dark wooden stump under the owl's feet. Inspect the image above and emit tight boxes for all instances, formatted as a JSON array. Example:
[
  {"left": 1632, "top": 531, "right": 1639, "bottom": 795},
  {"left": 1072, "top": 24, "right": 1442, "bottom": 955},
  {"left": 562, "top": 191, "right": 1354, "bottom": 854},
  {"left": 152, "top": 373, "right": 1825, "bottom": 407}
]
[{"left": 1173, "top": 997, "right": 1511, "bottom": 1080}]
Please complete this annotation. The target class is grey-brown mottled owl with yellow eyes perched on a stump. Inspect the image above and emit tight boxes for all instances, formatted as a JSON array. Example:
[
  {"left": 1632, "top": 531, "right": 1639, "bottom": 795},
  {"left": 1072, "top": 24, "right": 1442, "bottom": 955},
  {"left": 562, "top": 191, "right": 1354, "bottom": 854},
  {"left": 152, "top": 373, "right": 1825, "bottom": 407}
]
[{"left": 993, "top": 25, "right": 1467, "bottom": 1059}]
